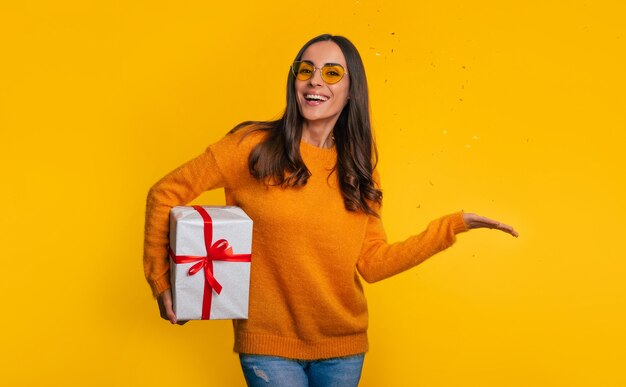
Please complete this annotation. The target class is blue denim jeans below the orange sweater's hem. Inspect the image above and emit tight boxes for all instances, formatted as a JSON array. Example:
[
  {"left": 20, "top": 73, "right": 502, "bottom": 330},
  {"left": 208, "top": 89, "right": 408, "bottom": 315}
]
[{"left": 239, "top": 354, "right": 365, "bottom": 387}]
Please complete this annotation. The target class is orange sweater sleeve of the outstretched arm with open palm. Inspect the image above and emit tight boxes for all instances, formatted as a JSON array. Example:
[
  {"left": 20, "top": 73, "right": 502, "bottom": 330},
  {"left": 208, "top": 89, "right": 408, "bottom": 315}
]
[{"left": 357, "top": 174, "right": 468, "bottom": 283}]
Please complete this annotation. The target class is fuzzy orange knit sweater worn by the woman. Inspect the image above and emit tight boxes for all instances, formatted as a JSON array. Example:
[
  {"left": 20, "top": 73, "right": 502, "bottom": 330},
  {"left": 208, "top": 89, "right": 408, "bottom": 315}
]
[{"left": 144, "top": 130, "right": 467, "bottom": 359}]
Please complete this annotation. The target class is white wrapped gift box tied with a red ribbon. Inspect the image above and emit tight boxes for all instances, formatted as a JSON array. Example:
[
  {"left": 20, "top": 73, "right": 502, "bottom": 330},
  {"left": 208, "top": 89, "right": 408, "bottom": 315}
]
[{"left": 170, "top": 206, "right": 252, "bottom": 320}]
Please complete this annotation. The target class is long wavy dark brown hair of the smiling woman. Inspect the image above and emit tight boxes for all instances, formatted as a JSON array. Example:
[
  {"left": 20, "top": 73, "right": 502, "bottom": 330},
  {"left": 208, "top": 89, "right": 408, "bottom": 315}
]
[{"left": 233, "top": 34, "right": 382, "bottom": 215}]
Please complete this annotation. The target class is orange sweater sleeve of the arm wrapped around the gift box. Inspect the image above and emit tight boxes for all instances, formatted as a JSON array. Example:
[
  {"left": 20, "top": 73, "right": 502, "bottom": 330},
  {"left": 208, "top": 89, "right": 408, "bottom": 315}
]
[{"left": 143, "top": 130, "right": 254, "bottom": 296}]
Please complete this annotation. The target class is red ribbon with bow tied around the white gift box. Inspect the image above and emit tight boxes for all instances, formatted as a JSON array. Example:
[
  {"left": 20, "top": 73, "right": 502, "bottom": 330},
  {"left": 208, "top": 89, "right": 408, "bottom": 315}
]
[{"left": 170, "top": 206, "right": 252, "bottom": 320}]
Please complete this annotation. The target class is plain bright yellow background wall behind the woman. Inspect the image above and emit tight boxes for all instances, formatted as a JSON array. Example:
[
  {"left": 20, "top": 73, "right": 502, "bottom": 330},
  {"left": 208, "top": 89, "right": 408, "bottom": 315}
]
[{"left": 0, "top": 0, "right": 626, "bottom": 387}]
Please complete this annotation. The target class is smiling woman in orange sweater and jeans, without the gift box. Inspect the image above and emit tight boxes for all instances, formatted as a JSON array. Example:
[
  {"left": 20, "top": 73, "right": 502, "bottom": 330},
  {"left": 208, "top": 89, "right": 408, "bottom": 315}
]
[{"left": 144, "top": 35, "right": 517, "bottom": 386}]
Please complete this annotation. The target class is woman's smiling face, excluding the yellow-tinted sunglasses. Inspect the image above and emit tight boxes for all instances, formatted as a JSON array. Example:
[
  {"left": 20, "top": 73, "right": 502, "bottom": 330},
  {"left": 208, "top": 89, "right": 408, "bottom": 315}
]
[{"left": 295, "top": 41, "right": 350, "bottom": 127}]
